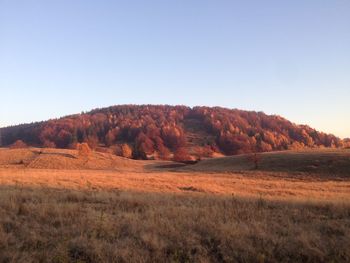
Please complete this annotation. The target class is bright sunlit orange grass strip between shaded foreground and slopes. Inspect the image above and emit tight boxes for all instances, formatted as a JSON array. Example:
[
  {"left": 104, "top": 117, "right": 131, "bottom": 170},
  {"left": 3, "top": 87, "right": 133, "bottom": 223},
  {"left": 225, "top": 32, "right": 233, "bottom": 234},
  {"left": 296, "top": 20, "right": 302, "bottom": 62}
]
[{"left": 0, "top": 169, "right": 350, "bottom": 201}]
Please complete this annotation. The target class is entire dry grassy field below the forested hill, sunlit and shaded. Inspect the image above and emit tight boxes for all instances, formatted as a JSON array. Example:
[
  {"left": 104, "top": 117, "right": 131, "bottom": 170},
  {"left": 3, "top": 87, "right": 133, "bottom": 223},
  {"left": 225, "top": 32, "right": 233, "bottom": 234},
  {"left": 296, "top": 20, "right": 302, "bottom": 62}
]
[{"left": 0, "top": 148, "right": 350, "bottom": 262}]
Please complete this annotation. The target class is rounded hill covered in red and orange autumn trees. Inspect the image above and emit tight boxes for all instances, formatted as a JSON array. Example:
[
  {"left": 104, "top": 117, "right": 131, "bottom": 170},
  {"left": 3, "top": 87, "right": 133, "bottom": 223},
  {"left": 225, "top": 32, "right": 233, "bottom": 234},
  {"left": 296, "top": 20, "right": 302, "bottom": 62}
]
[{"left": 1, "top": 105, "right": 344, "bottom": 159}]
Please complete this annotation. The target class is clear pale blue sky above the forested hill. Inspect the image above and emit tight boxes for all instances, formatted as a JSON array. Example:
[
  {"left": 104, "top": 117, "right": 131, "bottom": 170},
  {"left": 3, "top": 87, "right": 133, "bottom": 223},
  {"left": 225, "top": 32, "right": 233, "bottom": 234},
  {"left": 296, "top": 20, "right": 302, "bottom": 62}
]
[{"left": 0, "top": 0, "right": 350, "bottom": 137}]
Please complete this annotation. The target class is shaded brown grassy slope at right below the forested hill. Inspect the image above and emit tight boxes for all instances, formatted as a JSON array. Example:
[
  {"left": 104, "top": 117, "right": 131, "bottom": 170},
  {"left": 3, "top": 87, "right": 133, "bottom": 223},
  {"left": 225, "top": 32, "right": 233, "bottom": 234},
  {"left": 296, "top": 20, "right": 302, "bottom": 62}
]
[{"left": 181, "top": 149, "right": 350, "bottom": 178}]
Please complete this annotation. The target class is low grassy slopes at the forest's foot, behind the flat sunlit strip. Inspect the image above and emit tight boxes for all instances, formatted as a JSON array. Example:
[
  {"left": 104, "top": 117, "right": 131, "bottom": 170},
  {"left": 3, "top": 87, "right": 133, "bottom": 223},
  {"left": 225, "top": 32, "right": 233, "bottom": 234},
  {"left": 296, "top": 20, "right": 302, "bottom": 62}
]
[{"left": 0, "top": 148, "right": 350, "bottom": 178}]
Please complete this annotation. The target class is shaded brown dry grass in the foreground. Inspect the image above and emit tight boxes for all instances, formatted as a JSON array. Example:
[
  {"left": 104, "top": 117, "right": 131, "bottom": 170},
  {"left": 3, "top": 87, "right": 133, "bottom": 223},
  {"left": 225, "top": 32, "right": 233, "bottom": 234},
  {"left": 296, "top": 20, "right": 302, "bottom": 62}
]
[{"left": 0, "top": 186, "right": 350, "bottom": 262}]
